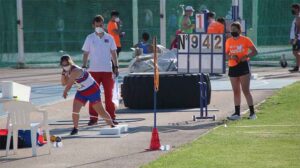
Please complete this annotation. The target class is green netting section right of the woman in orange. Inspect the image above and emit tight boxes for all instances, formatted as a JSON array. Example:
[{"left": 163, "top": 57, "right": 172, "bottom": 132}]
[{"left": 243, "top": 0, "right": 299, "bottom": 65}]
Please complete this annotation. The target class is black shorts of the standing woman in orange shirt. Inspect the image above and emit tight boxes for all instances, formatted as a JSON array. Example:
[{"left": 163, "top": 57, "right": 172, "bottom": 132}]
[{"left": 228, "top": 61, "right": 250, "bottom": 77}]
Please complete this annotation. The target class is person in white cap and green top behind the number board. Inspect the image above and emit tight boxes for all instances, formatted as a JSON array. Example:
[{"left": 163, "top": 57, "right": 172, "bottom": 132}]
[{"left": 179, "top": 6, "right": 195, "bottom": 33}]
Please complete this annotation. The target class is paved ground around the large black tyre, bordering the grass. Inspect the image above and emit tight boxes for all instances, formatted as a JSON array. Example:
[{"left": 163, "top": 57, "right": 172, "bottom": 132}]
[{"left": 0, "top": 68, "right": 300, "bottom": 168}]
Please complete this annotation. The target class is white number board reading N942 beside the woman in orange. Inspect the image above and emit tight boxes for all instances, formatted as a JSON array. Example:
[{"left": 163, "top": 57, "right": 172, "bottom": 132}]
[{"left": 177, "top": 33, "right": 225, "bottom": 73}]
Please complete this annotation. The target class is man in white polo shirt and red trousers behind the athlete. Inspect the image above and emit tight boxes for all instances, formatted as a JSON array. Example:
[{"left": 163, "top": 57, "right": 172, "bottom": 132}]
[{"left": 82, "top": 15, "right": 119, "bottom": 125}]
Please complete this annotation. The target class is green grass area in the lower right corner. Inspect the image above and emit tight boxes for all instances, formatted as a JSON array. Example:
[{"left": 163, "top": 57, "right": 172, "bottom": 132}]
[{"left": 143, "top": 83, "right": 300, "bottom": 168}]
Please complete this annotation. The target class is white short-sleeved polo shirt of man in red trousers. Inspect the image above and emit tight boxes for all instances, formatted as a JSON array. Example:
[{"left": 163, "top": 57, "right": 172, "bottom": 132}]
[{"left": 82, "top": 32, "right": 117, "bottom": 72}]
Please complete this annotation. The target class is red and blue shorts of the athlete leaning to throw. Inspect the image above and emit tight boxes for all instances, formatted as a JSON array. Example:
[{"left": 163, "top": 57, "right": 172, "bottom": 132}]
[{"left": 74, "top": 83, "right": 101, "bottom": 105}]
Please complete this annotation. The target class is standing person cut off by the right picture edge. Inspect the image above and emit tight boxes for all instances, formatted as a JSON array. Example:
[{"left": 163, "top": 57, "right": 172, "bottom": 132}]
[{"left": 289, "top": 4, "right": 300, "bottom": 72}]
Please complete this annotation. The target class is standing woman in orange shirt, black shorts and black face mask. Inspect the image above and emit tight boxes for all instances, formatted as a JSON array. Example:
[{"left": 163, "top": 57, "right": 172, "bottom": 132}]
[{"left": 225, "top": 22, "right": 257, "bottom": 120}]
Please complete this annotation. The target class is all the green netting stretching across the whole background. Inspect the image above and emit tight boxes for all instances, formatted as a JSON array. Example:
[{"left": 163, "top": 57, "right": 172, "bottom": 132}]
[{"left": 0, "top": 0, "right": 297, "bottom": 66}]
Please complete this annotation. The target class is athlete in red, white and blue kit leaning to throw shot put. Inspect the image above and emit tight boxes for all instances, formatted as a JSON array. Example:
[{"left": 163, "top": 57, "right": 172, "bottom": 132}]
[{"left": 60, "top": 55, "right": 114, "bottom": 135}]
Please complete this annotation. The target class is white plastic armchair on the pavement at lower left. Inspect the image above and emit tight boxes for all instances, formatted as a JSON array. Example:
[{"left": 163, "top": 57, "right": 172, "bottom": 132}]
[{"left": 3, "top": 100, "right": 51, "bottom": 156}]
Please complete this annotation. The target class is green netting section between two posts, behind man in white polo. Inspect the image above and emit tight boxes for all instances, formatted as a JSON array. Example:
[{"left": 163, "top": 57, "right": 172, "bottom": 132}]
[{"left": 23, "top": 0, "right": 132, "bottom": 52}]
